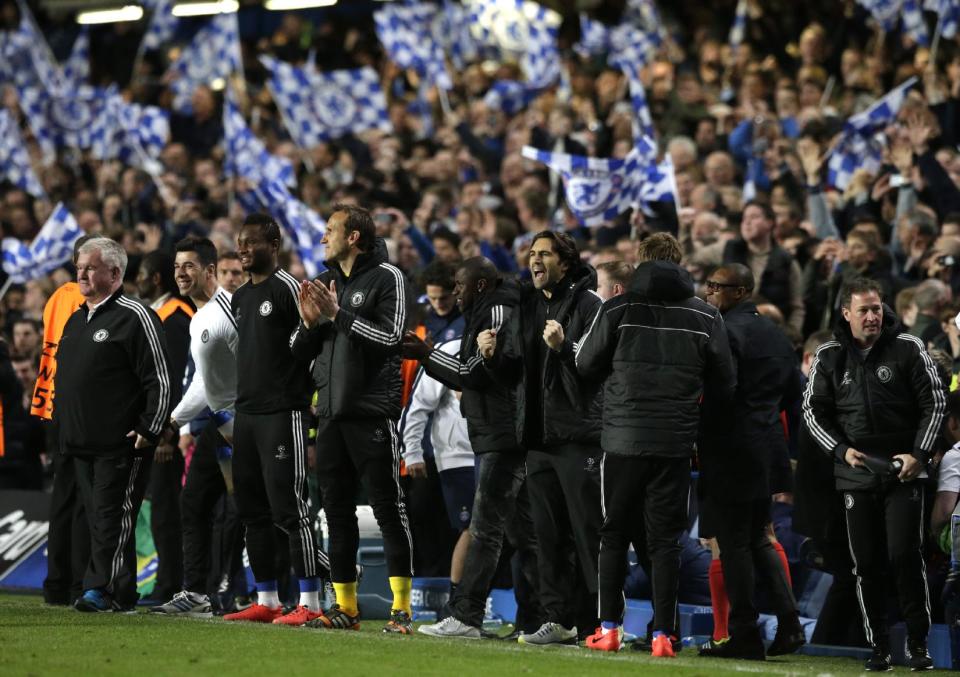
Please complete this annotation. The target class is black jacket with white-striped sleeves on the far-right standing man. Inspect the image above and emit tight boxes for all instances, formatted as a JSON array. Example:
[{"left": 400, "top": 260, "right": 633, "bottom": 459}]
[{"left": 803, "top": 306, "right": 946, "bottom": 490}]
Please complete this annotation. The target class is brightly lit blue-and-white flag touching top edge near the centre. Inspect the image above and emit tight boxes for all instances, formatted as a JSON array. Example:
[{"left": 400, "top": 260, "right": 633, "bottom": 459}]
[{"left": 470, "top": 0, "right": 562, "bottom": 87}]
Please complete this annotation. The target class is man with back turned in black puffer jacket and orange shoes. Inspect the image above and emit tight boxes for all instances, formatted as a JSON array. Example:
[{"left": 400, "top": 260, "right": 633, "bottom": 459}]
[{"left": 576, "top": 233, "right": 736, "bottom": 656}]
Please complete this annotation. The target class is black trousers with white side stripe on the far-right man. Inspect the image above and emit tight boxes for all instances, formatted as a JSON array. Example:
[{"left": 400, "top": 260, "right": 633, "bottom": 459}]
[{"left": 843, "top": 480, "right": 930, "bottom": 647}]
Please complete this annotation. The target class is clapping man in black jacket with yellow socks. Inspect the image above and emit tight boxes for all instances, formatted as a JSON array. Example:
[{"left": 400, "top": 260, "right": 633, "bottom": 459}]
[{"left": 290, "top": 205, "right": 413, "bottom": 634}]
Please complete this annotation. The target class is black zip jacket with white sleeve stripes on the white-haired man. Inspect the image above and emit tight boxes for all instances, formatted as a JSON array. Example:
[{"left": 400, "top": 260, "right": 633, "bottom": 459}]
[{"left": 54, "top": 290, "right": 174, "bottom": 456}]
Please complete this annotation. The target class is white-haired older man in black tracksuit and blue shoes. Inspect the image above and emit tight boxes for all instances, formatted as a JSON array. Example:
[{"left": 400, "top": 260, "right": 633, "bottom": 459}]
[{"left": 54, "top": 238, "right": 173, "bottom": 612}]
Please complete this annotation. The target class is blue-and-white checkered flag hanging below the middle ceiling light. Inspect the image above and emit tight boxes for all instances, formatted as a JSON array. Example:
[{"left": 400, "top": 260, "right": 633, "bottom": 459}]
[{"left": 168, "top": 13, "right": 243, "bottom": 114}]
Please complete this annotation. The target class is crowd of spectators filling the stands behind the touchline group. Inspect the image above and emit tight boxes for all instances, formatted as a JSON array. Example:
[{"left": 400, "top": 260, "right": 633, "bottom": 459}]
[{"left": 0, "top": 0, "right": 960, "bottom": 644}]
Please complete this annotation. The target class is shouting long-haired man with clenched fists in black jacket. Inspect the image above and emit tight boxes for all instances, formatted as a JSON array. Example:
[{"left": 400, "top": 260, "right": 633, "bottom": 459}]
[{"left": 480, "top": 230, "right": 603, "bottom": 645}]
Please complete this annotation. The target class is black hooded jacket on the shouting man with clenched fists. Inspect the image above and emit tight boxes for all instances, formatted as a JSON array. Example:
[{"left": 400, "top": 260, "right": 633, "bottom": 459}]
[{"left": 487, "top": 264, "right": 602, "bottom": 451}]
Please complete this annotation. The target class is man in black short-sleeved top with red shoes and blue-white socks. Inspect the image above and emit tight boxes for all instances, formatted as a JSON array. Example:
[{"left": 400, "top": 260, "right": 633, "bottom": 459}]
[{"left": 223, "top": 213, "right": 328, "bottom": 625}]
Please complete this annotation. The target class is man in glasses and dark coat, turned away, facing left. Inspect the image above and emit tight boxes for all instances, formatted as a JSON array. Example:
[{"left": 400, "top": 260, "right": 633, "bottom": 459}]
[{"left": 697, "top": 263, "right": 804, "bottom": 660}]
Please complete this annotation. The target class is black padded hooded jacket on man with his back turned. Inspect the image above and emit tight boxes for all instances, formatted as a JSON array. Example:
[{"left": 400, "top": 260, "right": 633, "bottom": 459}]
[{"left": 576, "top": 261, "right": 736, "bottom": 458}]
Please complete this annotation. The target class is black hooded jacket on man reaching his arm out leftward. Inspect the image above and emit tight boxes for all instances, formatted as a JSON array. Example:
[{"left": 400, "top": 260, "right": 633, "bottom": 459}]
[{"left": 423, "top": 280, "right": 520, "bottom": 454}]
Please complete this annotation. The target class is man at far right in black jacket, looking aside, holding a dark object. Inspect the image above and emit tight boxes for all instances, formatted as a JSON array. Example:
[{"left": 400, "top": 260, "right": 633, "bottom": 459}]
[{"left": 803, "top": 279, "right": 946, "bottom": 671}]
